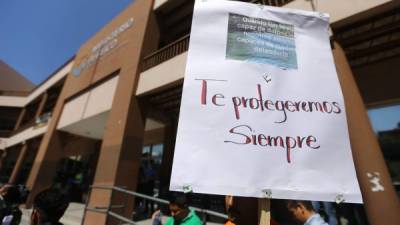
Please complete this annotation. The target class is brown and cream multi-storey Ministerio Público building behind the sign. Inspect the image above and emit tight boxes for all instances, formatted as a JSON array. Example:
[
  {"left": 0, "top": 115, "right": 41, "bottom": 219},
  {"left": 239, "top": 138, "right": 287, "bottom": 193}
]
[{"left": 0, "top": 0, "right": 400, "bottom": 224}]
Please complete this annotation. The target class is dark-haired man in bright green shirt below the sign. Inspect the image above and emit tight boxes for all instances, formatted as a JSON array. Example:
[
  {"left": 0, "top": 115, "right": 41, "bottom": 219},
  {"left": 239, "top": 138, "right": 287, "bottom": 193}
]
[{"left": 152, "top": 194, "right": 202, "bottom": 225}]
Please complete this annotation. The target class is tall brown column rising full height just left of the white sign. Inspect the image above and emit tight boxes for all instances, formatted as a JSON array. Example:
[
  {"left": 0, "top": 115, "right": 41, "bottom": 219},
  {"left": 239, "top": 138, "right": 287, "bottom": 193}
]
[{"left": 83, "top": 0, "right": 158, "bottom": 225}]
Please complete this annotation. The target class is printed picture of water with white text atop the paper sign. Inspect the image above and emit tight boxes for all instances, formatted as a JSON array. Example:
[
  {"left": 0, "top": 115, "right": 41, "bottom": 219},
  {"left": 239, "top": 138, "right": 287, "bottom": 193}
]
[{"left": 226, "top": 13, "right": 297, "bottom": 69}]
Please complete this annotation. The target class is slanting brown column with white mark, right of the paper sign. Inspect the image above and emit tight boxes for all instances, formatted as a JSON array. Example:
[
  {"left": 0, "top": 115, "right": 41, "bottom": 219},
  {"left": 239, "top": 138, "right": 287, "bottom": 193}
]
[{"left": 333, "top": 43, "right": 400, "bottom": 225}]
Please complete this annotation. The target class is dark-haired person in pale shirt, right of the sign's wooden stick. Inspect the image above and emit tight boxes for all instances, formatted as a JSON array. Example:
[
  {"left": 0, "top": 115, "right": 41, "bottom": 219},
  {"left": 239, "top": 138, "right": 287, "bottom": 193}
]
[{"left": 287, "top": 200, "right": 328, "bottom": 225}]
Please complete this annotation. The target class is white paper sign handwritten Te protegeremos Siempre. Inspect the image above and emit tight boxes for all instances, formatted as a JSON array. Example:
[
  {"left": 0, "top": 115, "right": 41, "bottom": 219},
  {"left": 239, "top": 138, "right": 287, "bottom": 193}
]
[{"left": 170, "top": 1, "right": 362, "bottom": 203}]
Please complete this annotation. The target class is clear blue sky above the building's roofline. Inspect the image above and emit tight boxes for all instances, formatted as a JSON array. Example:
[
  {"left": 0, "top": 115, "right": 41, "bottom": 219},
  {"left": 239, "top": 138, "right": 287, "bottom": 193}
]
[{"left": 0, "top": 0, "right": 133, "bottom": 84}]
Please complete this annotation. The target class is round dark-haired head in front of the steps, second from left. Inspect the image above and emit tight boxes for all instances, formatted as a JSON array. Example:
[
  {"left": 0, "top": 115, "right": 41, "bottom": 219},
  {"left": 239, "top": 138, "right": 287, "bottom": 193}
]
[{"left": 31, "top": 188, "right": 69, "bottom": 225}]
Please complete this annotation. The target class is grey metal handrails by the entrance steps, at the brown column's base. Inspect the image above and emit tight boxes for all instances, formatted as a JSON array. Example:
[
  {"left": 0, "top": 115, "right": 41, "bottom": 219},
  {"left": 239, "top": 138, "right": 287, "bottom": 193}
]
[{"left": 81, "top": 186, "right": 228, "bottom": 225}]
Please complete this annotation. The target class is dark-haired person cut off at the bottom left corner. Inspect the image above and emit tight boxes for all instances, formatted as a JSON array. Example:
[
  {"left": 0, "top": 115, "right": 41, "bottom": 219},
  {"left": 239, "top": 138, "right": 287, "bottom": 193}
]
[{"left": 0, "top": 184, "right": 29, "bottom": 225}]
